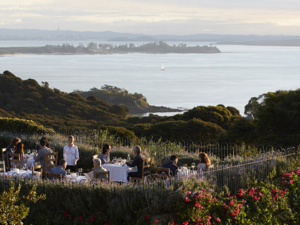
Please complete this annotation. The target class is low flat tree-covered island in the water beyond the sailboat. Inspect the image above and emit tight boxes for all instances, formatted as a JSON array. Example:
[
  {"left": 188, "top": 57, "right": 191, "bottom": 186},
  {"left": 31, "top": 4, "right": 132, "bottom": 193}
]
[{"left": 0, "top": 41, "right": 221, "bottom": 55}]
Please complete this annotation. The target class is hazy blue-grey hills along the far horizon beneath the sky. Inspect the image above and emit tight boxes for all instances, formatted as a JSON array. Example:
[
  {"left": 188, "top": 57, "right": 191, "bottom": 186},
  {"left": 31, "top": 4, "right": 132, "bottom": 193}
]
[{"left": 0, "top": 28, "right": 300, "bottom": 42}]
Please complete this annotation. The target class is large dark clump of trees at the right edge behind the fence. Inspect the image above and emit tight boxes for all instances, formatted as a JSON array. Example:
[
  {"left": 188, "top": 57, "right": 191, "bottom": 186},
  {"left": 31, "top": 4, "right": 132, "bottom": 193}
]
[{"left": 220, "top": 89, "right": 300, "bottom": 146}]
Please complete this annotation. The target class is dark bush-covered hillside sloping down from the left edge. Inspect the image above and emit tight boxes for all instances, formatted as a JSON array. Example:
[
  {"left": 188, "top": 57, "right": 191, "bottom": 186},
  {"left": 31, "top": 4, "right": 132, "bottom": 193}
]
[{"left": 0, "top": 71, "right": 129, "bottom": 129}]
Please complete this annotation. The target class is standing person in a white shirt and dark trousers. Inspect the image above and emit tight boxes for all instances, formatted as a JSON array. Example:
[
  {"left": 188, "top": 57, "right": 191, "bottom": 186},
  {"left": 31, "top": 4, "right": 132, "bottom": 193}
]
[{"left": 64, "top": 135, "right": 79, "bottom": 172}]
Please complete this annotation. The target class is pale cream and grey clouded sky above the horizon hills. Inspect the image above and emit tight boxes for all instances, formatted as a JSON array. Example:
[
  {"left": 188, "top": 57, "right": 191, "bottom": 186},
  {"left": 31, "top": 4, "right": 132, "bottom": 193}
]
[{"left": 0, "top": 0, "right": 300, "bottom": 35}]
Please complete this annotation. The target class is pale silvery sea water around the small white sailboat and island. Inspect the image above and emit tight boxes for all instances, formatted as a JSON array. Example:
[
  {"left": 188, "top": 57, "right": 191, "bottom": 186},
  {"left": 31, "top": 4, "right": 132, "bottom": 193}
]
[{"left": 0, "top": 41, "right": 300, "bottom": 115}]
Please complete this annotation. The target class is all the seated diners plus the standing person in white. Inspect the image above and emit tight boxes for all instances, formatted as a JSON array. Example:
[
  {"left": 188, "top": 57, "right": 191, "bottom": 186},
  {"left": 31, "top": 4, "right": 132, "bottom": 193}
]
[{"left": 5, "top": 136, "right": 211, "bottom": 180}]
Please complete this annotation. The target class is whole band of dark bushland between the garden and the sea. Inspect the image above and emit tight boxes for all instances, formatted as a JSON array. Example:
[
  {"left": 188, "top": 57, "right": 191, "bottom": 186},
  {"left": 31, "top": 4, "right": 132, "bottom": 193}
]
[{"left": 0, "top": 71, "right": 300, "bottom": 147}]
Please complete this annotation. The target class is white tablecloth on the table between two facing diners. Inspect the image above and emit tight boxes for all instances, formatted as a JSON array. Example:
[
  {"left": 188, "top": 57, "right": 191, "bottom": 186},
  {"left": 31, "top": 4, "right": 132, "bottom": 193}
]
[{"left": 102, "top": 164, "right": 137, "bottom": 183}]
